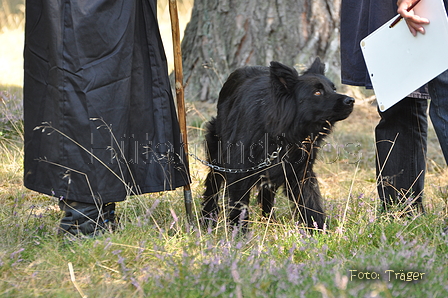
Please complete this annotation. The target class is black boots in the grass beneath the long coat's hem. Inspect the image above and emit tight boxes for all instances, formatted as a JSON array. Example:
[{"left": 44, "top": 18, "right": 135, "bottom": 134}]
[{"left": 59, "top": 200, "right": 115, "bottom": 236}]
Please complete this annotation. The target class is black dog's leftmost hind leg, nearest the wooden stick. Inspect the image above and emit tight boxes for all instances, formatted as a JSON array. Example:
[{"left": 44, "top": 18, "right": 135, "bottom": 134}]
[{"left": 201, "top": 170, "right": 224, "bottom": 226}]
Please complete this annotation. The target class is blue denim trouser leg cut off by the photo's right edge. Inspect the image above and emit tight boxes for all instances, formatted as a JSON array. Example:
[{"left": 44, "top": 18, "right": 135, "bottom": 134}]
[{"left": 428, "top": 71, "right": 448, "bottom": 164}]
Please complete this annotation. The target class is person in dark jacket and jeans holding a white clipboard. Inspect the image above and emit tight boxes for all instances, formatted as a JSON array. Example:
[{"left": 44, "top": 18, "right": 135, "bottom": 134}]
[{"left": 341, "top": 0, "right": 448, "bottom": 219}]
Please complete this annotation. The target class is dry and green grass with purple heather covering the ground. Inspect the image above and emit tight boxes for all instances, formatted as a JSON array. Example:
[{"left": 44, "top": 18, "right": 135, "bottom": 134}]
[{"left": 0, "top": 1, "right": 448, "bottom": 297}]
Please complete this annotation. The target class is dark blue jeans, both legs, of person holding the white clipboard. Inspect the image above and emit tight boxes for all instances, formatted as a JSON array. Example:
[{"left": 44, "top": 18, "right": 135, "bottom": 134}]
[{"left": 375, "top": 71, "right": 448, "bottom": 212}]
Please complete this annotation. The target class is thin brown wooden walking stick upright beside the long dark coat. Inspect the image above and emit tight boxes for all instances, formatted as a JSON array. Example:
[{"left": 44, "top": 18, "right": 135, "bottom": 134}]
[{"left": 169, "top": 0, "right": 193, "bottom": 224}]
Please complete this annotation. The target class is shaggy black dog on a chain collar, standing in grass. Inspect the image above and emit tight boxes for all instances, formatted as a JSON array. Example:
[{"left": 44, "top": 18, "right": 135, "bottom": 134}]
[{"left": 202, "top": 58, "right": 354, "bottom": 228}]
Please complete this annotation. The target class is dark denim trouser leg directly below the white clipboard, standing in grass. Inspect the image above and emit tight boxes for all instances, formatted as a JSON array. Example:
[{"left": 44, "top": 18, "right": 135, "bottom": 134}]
[{"left": 375, "top": 97, "right": 428, "bottom": 212}]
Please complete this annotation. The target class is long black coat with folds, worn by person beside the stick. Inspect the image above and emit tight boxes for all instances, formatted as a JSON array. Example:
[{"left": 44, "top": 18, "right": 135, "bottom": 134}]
[{"left": 24, "top": 0, "right": 189, "bottom": 203}]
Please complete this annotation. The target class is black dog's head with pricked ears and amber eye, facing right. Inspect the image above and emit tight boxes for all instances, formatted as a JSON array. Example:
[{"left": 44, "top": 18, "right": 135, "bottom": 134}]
[{"left": 270, "top": 58, "right": 355, "bottom": 139}]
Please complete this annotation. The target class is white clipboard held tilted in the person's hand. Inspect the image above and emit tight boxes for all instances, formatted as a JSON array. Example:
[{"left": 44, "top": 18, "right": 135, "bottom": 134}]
[{"left": 360, "top": 0, "right": 448, "bottom": 111}]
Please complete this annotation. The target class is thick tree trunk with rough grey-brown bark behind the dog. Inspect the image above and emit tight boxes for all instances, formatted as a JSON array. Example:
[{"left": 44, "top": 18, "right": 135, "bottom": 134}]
[{"left": 182, "top": 0, "right": 341, "bottom": 101}]
